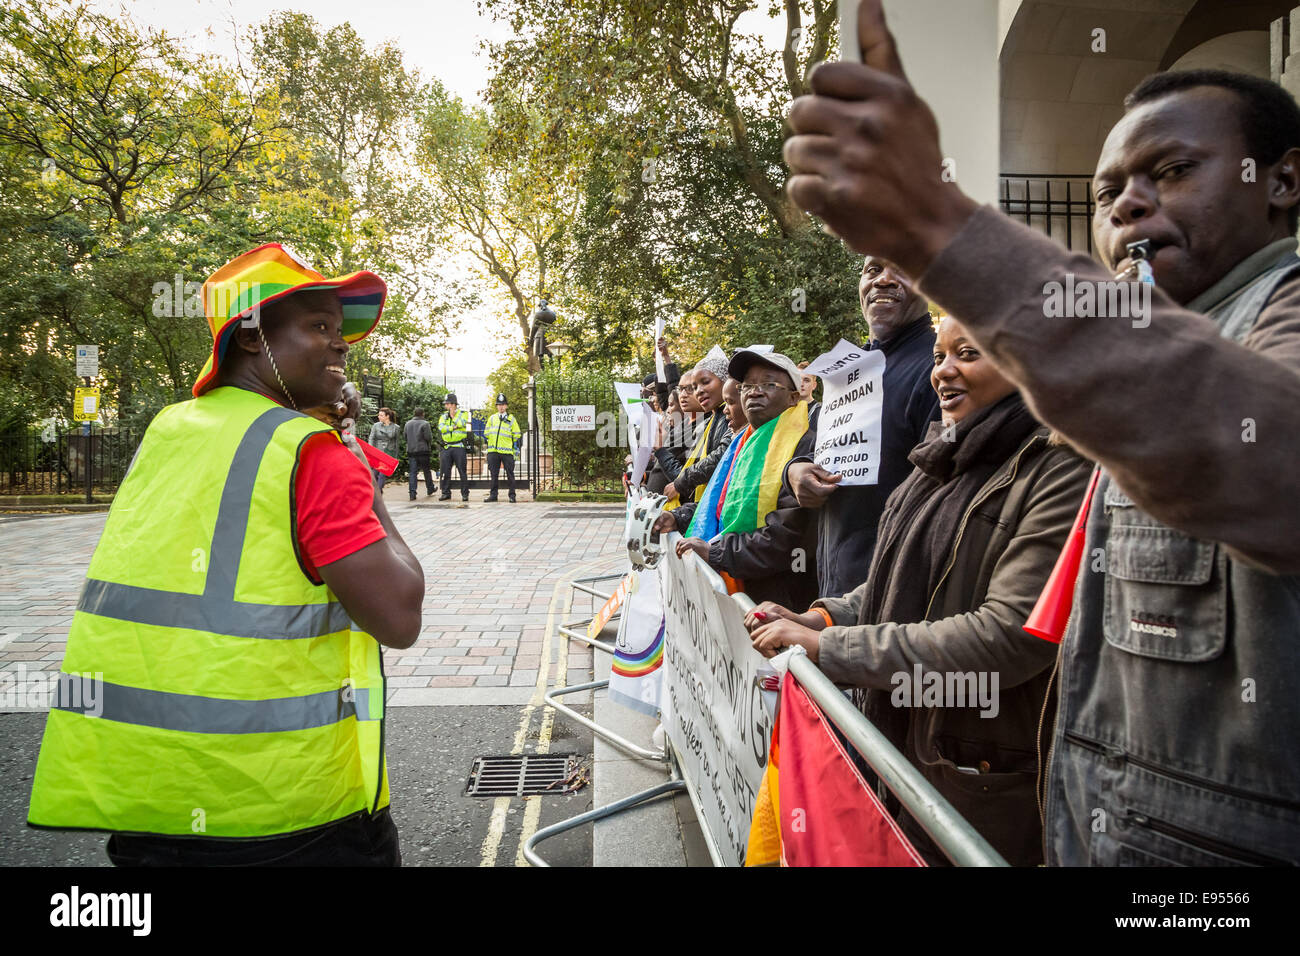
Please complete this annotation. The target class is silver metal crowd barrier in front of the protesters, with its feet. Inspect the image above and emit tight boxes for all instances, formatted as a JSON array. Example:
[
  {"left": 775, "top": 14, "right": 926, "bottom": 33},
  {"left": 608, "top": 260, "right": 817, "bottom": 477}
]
[{"left": 524, "top": 532, "right": 1009, "bottom": 866}]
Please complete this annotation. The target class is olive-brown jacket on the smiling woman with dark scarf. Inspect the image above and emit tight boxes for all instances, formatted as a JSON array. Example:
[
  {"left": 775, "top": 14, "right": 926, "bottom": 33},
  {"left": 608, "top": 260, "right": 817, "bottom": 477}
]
[{"left": 815, "top": 424, "right": 1091, "bottom": 865}]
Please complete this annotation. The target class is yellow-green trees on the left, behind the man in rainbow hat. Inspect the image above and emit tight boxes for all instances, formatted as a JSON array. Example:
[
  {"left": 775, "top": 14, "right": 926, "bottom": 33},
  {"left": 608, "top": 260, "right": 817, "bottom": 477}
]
[{"left": 0, "top": 0, "right": 475, "bottom": 425}]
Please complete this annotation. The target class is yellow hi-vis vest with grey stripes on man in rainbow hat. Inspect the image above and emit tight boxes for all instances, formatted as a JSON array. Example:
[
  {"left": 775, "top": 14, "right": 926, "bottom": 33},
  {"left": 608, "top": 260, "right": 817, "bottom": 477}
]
[{"left": 27, "top": 388, "right": 389, "bottom": 836}]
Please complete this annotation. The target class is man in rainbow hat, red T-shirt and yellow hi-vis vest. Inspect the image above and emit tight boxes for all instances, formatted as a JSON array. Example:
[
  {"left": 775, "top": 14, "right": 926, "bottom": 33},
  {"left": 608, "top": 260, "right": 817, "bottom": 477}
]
[{"left": 27, "top": 243, "right": 424, "bottom": 865}]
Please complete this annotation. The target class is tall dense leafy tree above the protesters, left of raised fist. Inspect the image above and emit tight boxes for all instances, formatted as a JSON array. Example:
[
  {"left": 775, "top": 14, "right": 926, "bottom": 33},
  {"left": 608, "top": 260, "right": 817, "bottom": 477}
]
[{"left": 485, "top": 0, "right": 861, "bottom": 367}]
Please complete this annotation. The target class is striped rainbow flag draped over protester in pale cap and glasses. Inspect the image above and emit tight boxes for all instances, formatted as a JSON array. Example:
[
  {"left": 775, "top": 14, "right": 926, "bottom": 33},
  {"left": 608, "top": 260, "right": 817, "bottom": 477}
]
[{"left": 690, "top": 402, "right": 809, "bottom": 541}]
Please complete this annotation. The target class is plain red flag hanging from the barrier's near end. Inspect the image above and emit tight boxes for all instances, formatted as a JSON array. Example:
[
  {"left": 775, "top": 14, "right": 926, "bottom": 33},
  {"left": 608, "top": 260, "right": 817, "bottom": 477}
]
[{"left": 776, "top": 674, "right": 926, "bottom": 866}]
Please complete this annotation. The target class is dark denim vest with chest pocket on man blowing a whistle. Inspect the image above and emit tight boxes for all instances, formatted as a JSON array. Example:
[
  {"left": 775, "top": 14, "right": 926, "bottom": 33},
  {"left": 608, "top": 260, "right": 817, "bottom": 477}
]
[{"left": 1044, "top": 259, "right": 1300, "bottom": 866}]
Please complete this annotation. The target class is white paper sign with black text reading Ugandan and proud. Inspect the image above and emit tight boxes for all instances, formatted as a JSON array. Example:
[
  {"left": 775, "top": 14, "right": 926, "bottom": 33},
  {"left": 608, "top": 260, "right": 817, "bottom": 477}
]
[{"left": 805, "top": 338, "right": 885, "bottom": 485}]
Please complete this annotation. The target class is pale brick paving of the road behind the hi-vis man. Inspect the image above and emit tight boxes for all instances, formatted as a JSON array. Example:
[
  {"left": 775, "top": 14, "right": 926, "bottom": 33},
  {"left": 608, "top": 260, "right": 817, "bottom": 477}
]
[{"left": 0, "top": 494, "right": 623, "bottom": 706}]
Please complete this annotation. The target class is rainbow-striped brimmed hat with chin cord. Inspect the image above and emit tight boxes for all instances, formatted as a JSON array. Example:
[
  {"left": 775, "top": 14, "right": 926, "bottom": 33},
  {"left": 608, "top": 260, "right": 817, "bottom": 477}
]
[{"left": 194, "top": 242, "right": 389, "bottom": 398}]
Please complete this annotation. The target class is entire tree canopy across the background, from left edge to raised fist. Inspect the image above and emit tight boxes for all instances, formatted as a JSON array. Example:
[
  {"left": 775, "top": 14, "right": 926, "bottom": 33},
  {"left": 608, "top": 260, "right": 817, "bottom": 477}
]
[{"left": 0, "top": 0, "right": 863, "bottom": 428}]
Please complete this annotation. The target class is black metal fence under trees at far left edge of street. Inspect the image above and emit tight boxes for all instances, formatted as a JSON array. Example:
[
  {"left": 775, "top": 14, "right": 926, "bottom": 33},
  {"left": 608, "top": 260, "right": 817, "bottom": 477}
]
[{"left": 0, "top": 427, "right": 142, "bottom": 494}]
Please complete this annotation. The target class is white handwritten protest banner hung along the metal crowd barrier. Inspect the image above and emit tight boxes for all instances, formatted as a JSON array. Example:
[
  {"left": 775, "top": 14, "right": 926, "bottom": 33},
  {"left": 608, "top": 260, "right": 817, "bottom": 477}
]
[{"left": 659, "top": 554, "right": 776, "bottom": 866}]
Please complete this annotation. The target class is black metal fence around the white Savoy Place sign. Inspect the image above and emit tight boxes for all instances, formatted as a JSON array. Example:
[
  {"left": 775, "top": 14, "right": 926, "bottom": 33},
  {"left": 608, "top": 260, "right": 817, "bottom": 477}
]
[{"left": 524, "top": 368, "right": 628, "bottom": 494}]
